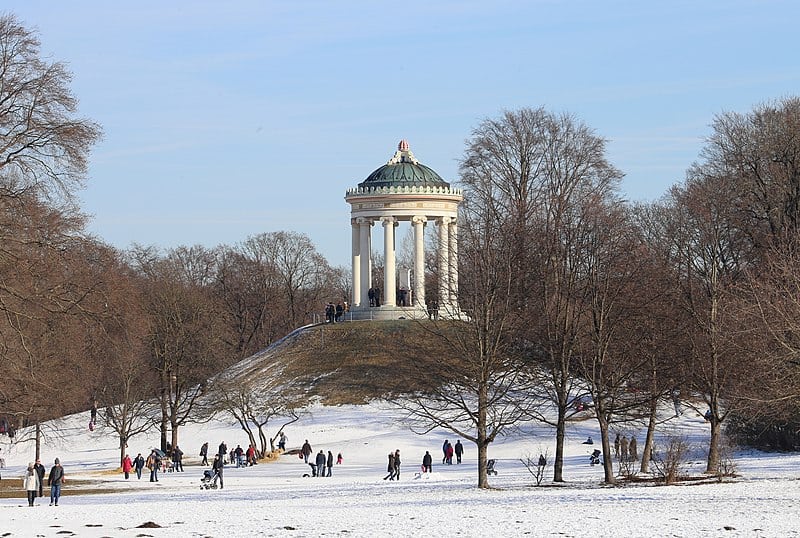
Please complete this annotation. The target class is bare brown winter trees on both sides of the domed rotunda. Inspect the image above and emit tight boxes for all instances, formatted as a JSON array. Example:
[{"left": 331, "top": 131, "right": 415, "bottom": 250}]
[{"left": 0, "top": 15, "right": 800, "bottom": 486}]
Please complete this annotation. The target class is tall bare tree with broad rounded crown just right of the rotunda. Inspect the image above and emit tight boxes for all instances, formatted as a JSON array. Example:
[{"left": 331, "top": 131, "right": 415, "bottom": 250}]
[{"left": 461, "top": 108, "right": 621, "bottom": 482}]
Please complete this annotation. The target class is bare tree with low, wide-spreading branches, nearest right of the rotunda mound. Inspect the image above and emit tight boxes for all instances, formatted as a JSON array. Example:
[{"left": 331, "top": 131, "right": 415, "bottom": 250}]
[{"left": 398, "top": 154, "right": 541, "bottom": 488}]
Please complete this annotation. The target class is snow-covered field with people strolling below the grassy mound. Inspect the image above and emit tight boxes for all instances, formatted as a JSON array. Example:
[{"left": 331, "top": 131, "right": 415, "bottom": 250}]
[{"left": 0, "top": 405, "right": 800, "bottom": 538}]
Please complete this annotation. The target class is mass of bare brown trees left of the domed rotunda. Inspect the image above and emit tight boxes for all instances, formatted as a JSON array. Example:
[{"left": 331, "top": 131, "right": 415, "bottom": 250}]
[{"left": 0, "top": 14, "right": 345, "bottom": 457}]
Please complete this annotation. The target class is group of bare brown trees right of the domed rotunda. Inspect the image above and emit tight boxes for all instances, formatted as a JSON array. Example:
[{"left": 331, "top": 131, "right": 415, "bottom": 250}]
[{"left": 401, "top": 102, "right": 800, "bottom": 487}]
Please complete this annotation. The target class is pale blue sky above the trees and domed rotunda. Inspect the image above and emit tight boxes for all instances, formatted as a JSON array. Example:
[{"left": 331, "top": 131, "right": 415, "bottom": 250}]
[{"left": 7, "top": 0, "right": 800, "bottom": 265}]
